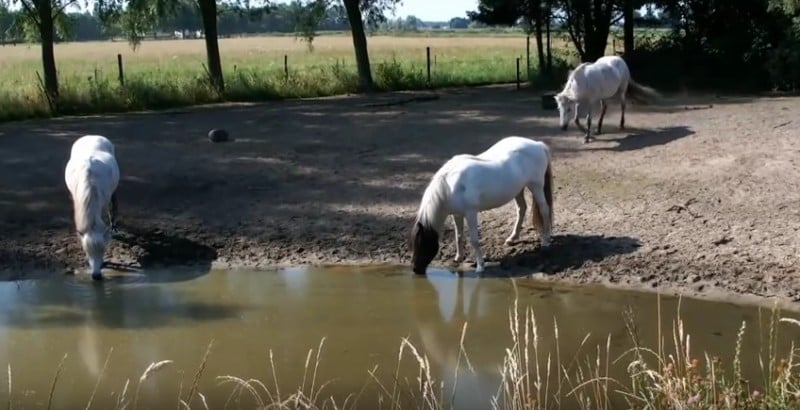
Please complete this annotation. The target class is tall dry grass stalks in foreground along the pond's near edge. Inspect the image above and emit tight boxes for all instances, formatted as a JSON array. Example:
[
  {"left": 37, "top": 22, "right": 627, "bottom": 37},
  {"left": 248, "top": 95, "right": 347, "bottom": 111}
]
[{"left": 8, "top": 290, "right": 800, "bottom": 410}]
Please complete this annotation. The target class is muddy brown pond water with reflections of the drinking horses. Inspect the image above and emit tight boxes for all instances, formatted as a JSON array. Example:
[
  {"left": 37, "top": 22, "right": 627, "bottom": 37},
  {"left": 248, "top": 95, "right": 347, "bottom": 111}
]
[{"left": 0, "top": 266, "right": 800, "bottom": 409}]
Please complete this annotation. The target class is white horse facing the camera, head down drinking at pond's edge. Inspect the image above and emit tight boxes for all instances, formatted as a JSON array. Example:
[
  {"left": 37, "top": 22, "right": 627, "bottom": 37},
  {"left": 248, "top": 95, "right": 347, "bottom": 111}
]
[{"left": 64, "top": 135, "right": 119, "bottom": 280}]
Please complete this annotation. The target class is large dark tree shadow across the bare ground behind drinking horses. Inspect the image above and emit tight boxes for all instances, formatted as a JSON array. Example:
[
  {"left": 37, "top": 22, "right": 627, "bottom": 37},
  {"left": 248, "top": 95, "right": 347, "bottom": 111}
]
[{"left": 0, "top": 86, "right": 764, "bottom": 266}]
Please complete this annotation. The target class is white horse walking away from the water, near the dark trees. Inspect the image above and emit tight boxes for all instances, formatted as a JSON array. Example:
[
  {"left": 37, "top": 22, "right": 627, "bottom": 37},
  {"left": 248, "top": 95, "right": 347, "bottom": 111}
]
[{"left": 555, "top": 56, "right": 659, "bottom": 142}]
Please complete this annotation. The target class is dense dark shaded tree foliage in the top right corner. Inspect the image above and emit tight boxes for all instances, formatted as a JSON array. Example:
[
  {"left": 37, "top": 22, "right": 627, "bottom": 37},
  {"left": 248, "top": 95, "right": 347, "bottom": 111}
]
[{"left": 626, "top": 0, "right": 800, "bottom": 91}]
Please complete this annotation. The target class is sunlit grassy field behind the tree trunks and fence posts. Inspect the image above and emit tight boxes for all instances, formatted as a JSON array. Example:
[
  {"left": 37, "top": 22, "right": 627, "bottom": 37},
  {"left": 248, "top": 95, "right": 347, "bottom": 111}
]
[{"left": 0, "top": 35, "right": 576, "bottom": 121}]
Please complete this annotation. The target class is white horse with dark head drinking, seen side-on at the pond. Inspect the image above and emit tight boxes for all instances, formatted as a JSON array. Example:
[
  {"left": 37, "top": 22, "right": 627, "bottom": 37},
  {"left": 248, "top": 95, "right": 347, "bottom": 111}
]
[{"left": 410, "top": 137, "right": 553, "bottom": 275}]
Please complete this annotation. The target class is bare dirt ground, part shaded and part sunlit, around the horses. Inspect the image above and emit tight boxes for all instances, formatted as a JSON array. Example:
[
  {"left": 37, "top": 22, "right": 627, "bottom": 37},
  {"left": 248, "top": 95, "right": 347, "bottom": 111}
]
[{"left": 0, "top": 86, "right": 800, "bottom": 301}]
